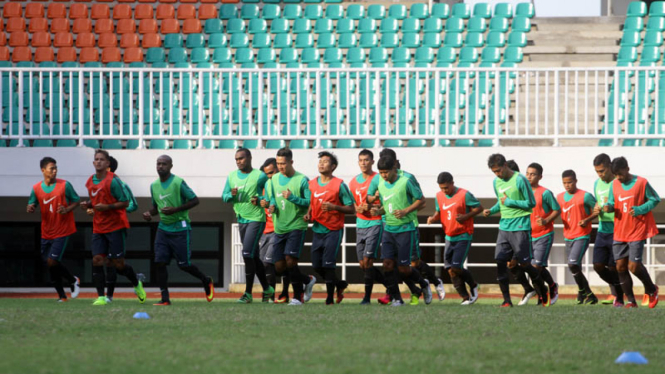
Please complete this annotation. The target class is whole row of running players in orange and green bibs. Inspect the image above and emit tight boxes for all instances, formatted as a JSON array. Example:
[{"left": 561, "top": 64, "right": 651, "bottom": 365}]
[{"left": 28, "top": 148, "right": 660, "bottom": 308}]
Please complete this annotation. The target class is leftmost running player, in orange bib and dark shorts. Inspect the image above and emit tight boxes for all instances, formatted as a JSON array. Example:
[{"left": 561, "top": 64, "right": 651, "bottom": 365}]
[{"left": 27, "top": 157, "right": 81, "bottom": 302}]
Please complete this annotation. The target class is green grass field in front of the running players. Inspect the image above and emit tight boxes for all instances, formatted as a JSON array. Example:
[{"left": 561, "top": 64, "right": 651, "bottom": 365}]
[{"left": 0, "top": 299, "right": 665, "bottom": 374}]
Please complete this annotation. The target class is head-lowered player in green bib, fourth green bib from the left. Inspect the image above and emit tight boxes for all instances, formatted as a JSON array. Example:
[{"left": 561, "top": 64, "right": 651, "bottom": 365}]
[{"left": 371, "top": 156, "right": 432, "bottom": 306}]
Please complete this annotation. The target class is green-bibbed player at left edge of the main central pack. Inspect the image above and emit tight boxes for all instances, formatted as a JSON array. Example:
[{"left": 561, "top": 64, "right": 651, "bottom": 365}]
[{"left": 222, "top": 148, "right": 275, "bottom": 304}]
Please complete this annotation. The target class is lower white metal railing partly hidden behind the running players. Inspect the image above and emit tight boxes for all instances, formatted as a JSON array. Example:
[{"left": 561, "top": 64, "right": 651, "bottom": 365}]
[{"left": 231, "top": 223, "right": 665, "bottom": 285}]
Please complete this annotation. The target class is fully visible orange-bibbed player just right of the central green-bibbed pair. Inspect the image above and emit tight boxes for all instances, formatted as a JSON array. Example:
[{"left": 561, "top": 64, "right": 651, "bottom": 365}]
[{"left": 305, "top": 151, "right": 355, "bottom": 305}]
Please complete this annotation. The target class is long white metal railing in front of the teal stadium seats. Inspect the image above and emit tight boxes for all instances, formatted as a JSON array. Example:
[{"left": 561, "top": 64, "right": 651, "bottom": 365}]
[{"left": 0, "top": 66, "right": 665, "bottom": 148}]
